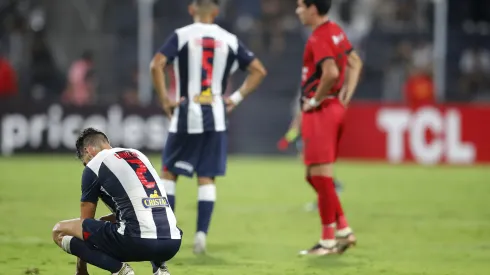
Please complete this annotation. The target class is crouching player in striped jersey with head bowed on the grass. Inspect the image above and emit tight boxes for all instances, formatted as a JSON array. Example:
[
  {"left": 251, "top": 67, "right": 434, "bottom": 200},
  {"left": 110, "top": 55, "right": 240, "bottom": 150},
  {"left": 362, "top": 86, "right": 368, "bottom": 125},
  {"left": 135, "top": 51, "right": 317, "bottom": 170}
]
[{"left": 53, "top": 128, "right": 182, "bottom": 275}]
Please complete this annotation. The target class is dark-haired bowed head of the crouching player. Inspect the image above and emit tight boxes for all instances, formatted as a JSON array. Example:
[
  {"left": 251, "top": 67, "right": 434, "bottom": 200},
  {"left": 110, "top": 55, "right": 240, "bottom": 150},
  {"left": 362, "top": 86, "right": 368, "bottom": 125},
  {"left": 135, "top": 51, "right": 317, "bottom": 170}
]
[{"left": 76, "top": 128, "right": 112, "bottom": 166}]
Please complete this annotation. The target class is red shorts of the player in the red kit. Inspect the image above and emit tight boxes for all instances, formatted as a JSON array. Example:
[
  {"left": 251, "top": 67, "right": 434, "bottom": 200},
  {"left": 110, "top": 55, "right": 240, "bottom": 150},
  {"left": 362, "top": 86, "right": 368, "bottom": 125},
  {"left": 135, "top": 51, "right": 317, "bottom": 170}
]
[{"left": 301, "top": 98, "right": 345, "bottom": 165}]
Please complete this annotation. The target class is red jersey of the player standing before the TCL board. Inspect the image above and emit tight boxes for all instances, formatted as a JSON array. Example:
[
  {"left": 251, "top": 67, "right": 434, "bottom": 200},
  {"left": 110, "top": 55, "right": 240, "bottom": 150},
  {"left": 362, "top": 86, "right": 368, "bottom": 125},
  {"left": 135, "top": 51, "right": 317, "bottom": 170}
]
[{"left": 301, "top": 21, "right": 352, "bottom": 98}]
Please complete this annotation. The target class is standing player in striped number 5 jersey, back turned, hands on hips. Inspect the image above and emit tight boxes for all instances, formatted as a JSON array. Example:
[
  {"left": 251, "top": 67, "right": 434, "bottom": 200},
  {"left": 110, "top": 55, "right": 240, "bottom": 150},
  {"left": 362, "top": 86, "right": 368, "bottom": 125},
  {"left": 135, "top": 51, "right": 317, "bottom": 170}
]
[{"left": 151, "top": 0, "right": 266, "bottom": 254}]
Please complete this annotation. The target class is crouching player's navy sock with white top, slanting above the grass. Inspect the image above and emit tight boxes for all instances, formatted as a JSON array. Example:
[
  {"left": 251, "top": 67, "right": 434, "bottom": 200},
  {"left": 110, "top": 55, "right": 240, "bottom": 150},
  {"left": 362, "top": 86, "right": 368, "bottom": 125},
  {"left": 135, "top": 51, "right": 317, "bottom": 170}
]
[{"left": 61, "top": 236, "right": 123, "bottom": 273}]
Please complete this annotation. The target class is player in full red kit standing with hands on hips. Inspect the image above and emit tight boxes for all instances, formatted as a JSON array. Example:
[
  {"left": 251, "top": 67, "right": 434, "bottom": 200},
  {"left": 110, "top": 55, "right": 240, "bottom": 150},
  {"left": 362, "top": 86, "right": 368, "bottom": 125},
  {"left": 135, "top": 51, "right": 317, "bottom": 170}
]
[{"left": 296, "top": 0, "right": 362, "bottom": 255}]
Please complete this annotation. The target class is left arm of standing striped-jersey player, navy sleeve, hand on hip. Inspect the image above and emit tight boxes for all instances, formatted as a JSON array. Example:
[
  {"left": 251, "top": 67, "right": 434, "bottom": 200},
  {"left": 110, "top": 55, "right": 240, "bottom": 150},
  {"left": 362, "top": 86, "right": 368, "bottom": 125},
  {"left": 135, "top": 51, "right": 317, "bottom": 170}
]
[{"left": 150, "top": 33, "right": 183, "bottom": 117}]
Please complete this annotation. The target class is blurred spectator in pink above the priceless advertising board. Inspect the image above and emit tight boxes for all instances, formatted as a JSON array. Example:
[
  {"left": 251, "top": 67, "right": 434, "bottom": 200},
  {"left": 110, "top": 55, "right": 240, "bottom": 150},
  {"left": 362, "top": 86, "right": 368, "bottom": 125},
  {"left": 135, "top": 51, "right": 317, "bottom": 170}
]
[{"left": 63, "top": 50, "right": 95, "bottom": 106}]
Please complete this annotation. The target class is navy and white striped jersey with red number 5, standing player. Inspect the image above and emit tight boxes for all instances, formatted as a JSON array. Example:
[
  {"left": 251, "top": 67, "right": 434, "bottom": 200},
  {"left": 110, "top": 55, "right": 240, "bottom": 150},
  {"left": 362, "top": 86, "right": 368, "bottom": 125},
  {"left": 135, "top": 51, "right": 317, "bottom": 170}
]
[{"left": 159, "top": 23, "right": 255, "bottom": 134}]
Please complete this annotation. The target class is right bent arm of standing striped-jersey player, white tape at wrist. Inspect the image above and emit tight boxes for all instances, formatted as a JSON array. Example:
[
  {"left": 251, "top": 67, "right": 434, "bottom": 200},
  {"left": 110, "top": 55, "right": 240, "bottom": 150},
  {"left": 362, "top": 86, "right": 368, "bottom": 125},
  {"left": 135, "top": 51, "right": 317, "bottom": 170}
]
[{"left": 227, "top": 42, "right": 267, "bottom": 111}]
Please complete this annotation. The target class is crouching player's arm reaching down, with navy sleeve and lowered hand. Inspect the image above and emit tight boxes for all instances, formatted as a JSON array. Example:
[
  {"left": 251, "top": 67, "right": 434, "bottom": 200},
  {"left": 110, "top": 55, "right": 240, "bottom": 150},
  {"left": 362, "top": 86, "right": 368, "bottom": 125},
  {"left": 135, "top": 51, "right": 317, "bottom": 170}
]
[{"left": 77, "top": 167, "right": 100, "bottom": 274}]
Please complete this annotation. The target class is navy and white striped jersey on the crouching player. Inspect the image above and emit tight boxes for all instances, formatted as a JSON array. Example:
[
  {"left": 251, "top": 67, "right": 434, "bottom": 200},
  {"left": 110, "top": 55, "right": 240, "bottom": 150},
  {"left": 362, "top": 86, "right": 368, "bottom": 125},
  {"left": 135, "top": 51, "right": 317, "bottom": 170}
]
[{"left": 81, "top": 148, "right": 181, "bottom": 239}]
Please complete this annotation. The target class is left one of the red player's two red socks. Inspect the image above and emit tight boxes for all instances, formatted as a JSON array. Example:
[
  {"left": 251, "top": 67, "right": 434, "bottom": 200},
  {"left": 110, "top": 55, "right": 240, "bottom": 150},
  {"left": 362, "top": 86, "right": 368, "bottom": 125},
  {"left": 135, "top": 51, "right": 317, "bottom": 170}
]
[{"left": 311, "top": 176, "right": 336, "bottom": 240}]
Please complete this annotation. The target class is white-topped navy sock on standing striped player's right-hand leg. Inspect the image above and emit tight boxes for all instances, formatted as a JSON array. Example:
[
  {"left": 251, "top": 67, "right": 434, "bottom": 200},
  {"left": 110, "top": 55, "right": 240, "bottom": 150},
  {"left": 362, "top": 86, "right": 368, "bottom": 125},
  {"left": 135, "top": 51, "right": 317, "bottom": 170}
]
[{"left": 197, "top": 184, "right": 216, "bottom": 234}]
